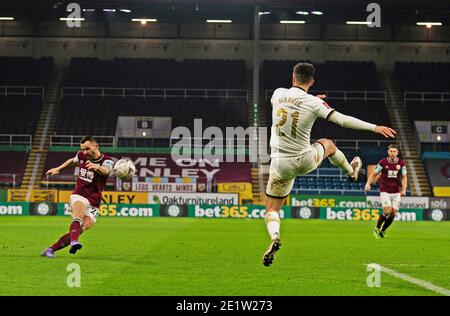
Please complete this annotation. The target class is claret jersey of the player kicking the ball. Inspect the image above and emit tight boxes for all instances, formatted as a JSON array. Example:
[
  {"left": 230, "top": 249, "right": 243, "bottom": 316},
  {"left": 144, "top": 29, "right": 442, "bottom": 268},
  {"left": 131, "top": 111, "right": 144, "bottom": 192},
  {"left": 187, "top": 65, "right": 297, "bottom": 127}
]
[{"left": 73, "top": 151, "right": 114, "bottom": 208}]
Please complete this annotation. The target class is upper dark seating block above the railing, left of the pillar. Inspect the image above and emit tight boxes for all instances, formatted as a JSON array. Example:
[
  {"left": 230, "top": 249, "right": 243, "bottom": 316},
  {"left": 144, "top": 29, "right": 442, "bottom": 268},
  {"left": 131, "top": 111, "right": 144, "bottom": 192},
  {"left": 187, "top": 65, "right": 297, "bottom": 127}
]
[{"left": 65, "top": 58, "right": 247, "bottom": 89}]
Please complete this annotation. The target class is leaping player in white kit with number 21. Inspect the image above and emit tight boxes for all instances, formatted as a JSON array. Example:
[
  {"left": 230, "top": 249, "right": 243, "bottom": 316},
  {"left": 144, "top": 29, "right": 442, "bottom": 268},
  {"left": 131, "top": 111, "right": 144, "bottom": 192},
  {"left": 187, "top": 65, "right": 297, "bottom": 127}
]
[{"left": 263, "top": 63, "right": 396, "bottom": 266}]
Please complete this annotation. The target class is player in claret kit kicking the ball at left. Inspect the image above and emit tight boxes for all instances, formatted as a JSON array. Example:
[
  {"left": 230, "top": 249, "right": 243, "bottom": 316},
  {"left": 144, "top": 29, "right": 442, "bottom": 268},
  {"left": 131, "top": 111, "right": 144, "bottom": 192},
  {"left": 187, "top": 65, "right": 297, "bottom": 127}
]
[{"left": 41, "top": 136, "right": 114, "bottom": 258}]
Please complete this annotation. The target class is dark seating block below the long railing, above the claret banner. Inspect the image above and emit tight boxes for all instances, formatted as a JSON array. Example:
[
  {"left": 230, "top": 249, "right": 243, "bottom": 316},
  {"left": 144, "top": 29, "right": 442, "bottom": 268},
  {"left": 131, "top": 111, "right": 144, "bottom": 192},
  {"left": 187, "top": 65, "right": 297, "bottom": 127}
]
[{"left": 55, "top": 97, "right": 248, "bottom": 135}]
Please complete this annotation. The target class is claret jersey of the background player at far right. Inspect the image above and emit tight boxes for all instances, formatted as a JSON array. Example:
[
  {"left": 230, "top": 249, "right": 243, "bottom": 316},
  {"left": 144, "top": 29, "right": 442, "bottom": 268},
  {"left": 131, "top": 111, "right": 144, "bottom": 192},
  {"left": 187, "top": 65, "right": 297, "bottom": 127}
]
[{"left": 375, "top": 158, "right": 406, "bottom": 193}]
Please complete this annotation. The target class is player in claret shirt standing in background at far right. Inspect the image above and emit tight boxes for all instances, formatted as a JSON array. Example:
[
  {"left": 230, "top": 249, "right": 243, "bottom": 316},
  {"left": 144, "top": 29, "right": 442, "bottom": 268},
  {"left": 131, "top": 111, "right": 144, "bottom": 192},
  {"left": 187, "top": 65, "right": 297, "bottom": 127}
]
[{"left": 364, "top": 145, "right": 408, "bottom": 239}]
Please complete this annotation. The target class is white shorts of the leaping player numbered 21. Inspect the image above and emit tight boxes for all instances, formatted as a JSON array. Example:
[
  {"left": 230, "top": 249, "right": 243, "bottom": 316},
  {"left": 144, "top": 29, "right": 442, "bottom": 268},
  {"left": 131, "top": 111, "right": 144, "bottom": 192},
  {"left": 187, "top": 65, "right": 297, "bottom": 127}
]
[{"left": 266, "top": 143, "right": 325, "bottom": 199}]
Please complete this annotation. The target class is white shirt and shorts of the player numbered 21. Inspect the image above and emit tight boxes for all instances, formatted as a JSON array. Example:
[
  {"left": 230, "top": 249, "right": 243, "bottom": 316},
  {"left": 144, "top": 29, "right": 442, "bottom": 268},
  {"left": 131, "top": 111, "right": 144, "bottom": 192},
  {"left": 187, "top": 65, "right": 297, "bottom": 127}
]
[{"left": 266, "top": 86, "right": 376, "bottom": 198}]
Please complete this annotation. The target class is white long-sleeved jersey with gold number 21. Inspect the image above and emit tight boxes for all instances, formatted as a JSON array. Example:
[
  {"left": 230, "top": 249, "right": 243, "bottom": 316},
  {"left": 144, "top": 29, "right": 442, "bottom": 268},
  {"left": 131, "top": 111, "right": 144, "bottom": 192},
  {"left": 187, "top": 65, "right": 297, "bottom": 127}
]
[{"left": 270, "top": 86, "right": 334, "bottom": 158}]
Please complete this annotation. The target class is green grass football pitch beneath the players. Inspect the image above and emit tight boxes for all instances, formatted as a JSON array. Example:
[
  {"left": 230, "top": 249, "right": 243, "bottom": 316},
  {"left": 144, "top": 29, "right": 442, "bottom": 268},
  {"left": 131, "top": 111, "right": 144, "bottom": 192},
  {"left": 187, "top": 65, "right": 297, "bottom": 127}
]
[{"left": 0, "top": 217, "right": 450, "bottom": 296}]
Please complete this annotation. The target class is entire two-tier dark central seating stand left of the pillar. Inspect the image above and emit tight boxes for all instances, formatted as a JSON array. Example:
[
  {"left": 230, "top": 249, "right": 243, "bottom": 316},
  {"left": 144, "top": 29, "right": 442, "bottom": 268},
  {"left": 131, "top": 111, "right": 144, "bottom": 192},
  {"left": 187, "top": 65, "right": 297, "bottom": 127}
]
[{"left": 54, "top": 58, "right": 248, "bottom": 146}]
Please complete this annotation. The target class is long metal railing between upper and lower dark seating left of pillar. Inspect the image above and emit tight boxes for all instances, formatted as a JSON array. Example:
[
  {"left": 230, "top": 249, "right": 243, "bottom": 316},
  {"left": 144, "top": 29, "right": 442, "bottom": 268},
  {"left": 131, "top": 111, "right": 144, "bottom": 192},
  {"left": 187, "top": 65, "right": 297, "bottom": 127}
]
[{"left": 61, "top": 87, "right": 248, "bottom": 101}]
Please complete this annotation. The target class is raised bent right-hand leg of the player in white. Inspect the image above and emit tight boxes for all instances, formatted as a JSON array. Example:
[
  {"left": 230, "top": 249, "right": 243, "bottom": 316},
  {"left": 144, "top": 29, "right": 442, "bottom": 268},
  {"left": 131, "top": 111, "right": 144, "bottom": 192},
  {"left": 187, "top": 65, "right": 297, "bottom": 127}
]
[{"left": 316, "top": 138, "right": 362, "bottom": 181}]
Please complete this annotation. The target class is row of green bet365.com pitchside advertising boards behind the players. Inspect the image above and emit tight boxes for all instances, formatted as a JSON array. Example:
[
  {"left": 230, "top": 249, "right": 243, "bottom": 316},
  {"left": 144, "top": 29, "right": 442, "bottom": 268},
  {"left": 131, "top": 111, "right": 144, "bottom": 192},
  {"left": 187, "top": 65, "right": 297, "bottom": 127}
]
[{"left": 0, "top": 191, "right": 450, "bottom": 221}]
